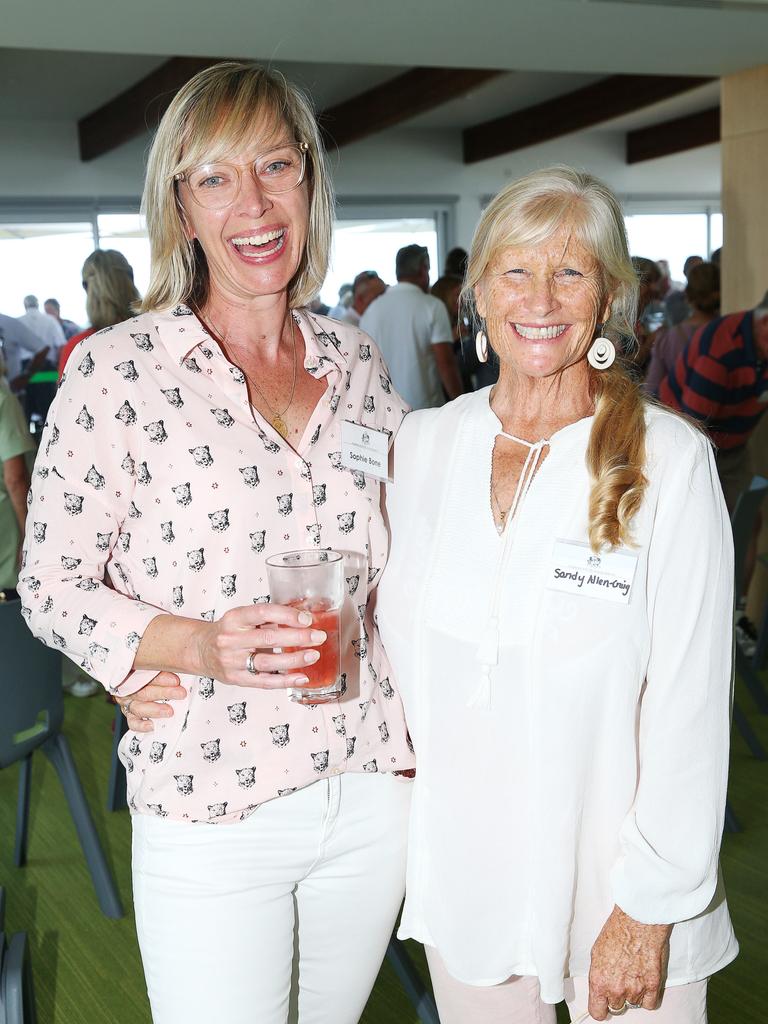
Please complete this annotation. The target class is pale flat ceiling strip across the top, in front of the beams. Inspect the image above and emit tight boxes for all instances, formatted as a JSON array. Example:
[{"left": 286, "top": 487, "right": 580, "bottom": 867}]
[{"left": 2, "top": 0, "right": 768, "bottom": 75}]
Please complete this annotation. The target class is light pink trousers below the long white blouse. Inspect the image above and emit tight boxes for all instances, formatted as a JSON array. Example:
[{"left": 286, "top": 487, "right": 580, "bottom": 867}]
[{"left": 425, "top": 946, "right": 707, "bottom": 1024}]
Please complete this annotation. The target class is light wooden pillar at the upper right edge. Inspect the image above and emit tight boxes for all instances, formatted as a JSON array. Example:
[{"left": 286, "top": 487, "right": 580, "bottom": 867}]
[{"left": 721, "top": 65, "right": 768, "bottom": 312}]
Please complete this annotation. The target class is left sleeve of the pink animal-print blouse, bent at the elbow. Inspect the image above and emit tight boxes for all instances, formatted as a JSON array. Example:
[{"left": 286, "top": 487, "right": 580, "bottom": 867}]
[{"left": 18, "top": 335, "right": 163, "bottom": 693}]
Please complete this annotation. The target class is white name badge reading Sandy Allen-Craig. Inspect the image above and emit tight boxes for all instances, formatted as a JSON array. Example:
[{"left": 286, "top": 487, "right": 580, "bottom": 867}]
[{"left": 547, "top": 541, "right": 637, "bottom": 604}]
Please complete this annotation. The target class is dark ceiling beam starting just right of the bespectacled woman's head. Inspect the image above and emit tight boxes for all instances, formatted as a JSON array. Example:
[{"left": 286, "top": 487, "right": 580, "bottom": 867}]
[{"left": 319, "top": 68, "right": 502, "bottom": 146}]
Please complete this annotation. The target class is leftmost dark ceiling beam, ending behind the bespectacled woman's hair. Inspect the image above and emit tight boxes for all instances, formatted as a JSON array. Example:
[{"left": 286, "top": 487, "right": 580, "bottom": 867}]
[{"left": 78, "top": 57, "right": 221, "bottom": 161}]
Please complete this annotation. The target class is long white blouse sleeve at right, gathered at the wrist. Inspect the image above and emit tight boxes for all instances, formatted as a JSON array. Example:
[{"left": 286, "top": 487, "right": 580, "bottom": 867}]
[{"left": 611, "top": 419, "right": 733, "bottom": 924}]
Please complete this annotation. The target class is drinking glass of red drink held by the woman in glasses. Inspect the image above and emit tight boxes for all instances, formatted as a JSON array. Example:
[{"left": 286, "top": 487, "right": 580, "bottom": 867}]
[{"left": 266, "top": 550, "right": 345, "bottom": 703}]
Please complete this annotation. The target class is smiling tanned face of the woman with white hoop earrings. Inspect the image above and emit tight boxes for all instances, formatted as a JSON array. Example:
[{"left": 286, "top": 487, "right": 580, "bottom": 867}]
[{"left": 476, "top": 227, "right": 609, "bottom": 378}]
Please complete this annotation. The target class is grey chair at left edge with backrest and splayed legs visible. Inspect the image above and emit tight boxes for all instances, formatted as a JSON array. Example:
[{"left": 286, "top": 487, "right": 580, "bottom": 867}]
[{"left": 0, "top": 601, "right": 124, "bottom": 921}]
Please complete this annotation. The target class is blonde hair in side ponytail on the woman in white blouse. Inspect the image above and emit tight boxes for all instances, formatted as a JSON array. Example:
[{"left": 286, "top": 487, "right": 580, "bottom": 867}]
[{"left": 463, "top": 167, "right": 647, "bottom": 551}]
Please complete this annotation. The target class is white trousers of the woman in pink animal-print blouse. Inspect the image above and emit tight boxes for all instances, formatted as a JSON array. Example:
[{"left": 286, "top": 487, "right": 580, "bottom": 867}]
[{"left": 133, "top": 773, "right": 411, "bottom": 1024}]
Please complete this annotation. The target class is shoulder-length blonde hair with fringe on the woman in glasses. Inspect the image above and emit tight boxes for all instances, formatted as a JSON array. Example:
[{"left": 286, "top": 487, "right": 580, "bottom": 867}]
[{"left": 141, "top": 60, "right": 334, "bottom": 311}]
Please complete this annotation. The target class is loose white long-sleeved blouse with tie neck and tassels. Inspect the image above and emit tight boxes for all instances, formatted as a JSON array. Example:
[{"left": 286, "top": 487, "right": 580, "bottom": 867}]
[{"left": 378, "top": 389, "right": 738, "bottom": 1002}]
